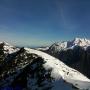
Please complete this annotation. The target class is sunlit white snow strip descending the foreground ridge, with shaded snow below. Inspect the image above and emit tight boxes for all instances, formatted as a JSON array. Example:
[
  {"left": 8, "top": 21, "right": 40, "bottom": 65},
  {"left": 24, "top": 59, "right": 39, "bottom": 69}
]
[{"left": 25, "top": 48, "right": 90, "bottom": 90}]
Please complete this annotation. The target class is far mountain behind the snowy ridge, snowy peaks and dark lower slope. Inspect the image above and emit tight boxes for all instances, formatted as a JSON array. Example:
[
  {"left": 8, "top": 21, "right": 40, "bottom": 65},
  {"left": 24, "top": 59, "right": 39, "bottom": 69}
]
[{"left": 44, "top": 38, "right": 90, "bottom": 78}]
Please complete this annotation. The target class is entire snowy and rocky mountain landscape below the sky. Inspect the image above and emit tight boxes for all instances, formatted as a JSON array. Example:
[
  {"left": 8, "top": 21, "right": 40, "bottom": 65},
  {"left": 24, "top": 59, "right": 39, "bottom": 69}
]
[{"left": 0, "top": 38, "right": 90, "bottom": 90}]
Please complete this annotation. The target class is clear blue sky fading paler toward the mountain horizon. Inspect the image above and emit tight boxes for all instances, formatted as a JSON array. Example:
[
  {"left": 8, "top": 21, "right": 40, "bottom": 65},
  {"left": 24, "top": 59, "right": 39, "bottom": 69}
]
[{"left": 0, "top": 0, "right": 90, "bottom": 46}]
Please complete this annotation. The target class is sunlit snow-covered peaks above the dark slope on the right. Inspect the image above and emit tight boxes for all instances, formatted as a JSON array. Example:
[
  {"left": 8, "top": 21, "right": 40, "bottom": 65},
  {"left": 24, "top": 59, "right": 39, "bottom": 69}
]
[{"left": 49, "top": 38, "right": 90, "bottom": 52}]
